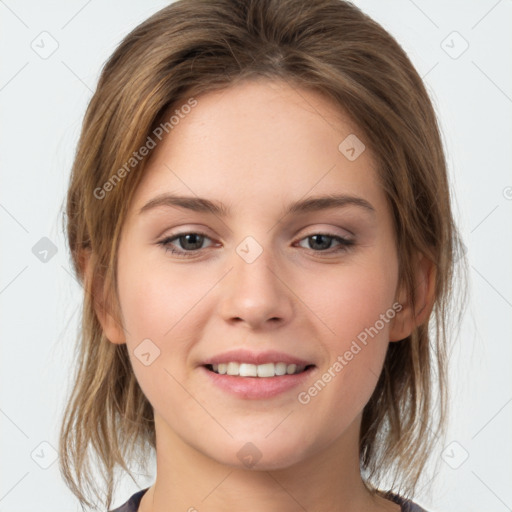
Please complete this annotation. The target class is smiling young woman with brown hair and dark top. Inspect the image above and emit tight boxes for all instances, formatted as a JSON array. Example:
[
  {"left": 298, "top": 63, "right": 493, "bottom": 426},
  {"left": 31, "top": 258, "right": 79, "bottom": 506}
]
[{"left": 60, "top": 0, "right": 468, "bottom": 512}]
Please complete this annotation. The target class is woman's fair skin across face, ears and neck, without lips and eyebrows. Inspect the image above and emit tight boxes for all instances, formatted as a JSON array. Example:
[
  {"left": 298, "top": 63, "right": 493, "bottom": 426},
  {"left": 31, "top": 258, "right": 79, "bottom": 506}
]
[{"left": 91, "top": 80, "right": 433, "bottom": 512}]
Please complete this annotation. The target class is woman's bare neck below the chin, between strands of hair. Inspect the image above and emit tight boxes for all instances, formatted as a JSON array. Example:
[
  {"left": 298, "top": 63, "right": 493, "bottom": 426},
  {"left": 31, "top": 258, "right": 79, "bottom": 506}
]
[{"left": 139, "top": 414, "right": 400, "bottom": 512}]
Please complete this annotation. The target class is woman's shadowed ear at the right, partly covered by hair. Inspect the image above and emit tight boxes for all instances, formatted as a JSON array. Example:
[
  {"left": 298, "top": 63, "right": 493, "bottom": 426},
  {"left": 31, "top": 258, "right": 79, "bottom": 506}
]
[{"left": 389, "top": 253, "right": 436, "bottom": 341}]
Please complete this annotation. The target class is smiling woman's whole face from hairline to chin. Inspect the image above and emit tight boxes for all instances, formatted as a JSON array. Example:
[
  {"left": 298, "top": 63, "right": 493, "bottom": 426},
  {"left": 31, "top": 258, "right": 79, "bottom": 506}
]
[{"left": 106, "top": 81, "right": 406, "bottom": 469}]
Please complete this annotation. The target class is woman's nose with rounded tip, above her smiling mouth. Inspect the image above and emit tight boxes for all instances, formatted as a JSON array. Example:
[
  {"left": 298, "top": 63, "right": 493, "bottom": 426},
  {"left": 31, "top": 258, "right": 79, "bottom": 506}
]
[{"left": 219, "top": 241, "right": 296, "bottom": 329}]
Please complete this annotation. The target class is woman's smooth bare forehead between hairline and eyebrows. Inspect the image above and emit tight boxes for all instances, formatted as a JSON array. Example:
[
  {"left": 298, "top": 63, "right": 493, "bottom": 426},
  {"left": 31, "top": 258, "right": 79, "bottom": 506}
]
[{"left": 130, "top": 80, "right": 383, "bottom": 218}]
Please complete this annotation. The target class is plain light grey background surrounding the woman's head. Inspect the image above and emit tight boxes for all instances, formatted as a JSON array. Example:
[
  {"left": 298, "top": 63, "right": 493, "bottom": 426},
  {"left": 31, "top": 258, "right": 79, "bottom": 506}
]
[{"left": 0, "top": 0, "right": 512, "bottom": 512}]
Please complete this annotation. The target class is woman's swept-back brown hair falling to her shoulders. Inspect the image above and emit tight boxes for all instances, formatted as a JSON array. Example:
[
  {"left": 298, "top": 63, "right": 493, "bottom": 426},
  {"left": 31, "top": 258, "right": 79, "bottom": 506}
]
[{"left": 59, "top": 0, "right": 466, "bottom": 509}]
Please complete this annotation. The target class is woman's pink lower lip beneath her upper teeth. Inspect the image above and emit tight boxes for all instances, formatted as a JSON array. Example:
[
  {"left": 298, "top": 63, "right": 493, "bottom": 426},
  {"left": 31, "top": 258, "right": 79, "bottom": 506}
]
[{"left": 200, "top": 366, "right": 316, "bottom": 400}]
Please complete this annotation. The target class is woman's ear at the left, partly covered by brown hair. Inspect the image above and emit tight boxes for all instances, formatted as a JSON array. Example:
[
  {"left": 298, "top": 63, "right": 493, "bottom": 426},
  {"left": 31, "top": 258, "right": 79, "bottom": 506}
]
[{"left": 79, "top": 249, "right": 126, "bottom": 345}]
